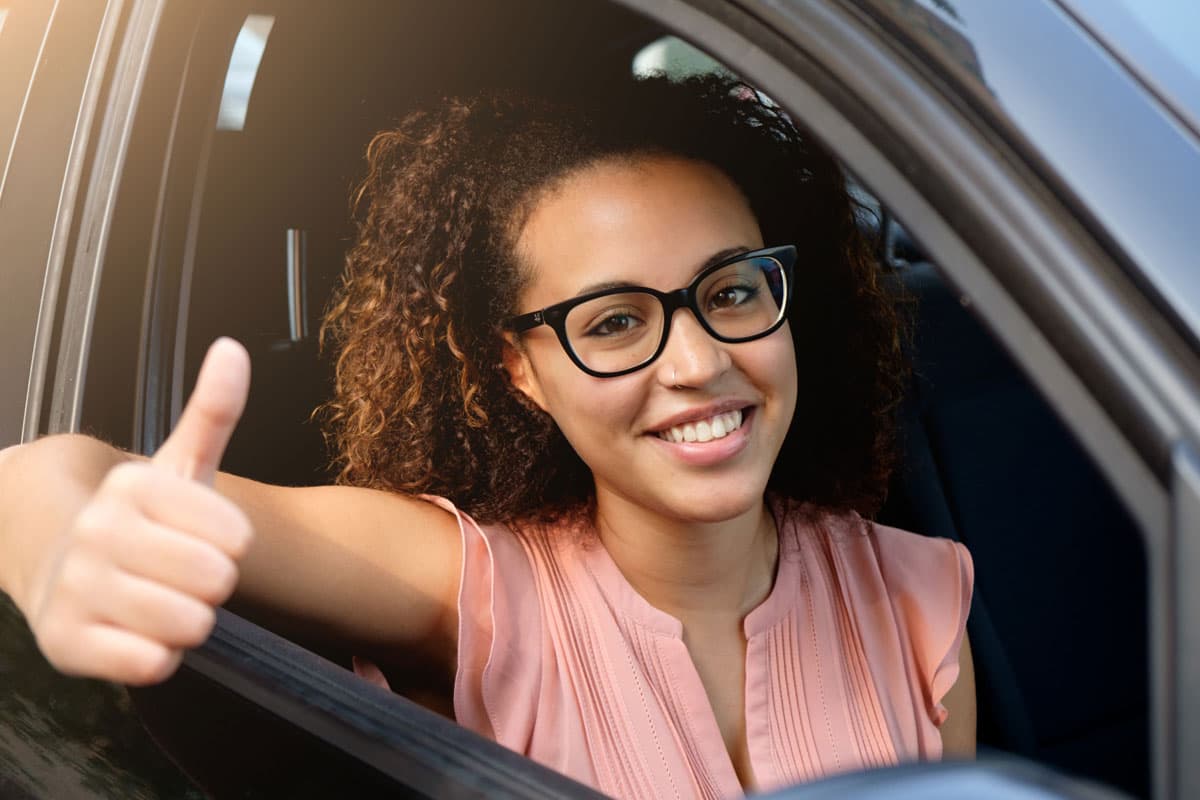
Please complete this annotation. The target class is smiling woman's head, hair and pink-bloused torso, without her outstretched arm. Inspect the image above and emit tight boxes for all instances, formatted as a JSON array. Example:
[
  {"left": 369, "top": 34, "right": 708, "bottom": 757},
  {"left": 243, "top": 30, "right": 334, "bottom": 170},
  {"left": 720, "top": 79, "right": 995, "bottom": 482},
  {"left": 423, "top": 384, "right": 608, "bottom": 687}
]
[{"left": 312, "top": 77, "right": 974, "bottom": 796}]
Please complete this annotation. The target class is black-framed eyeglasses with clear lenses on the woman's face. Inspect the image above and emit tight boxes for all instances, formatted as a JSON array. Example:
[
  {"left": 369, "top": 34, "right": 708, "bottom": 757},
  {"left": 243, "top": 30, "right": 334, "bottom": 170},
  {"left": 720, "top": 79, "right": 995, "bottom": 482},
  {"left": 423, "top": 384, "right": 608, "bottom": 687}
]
[{"left": 505, "top": 245, "right": 796, "bottom": 378}]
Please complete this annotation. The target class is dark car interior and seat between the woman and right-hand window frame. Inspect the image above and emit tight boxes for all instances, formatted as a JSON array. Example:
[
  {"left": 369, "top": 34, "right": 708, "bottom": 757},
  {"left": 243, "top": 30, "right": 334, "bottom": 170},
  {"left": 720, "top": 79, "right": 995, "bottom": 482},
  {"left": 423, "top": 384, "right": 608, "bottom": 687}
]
[{"left": 880, "top": 260, "right": 1150, "bottom": 796}]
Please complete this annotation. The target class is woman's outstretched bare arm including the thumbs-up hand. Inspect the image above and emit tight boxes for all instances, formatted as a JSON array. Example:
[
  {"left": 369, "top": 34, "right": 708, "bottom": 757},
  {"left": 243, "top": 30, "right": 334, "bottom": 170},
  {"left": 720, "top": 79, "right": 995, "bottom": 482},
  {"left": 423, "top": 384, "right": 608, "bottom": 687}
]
[{"left": 0, "top": 344, "right": 461, "bottom": 684}]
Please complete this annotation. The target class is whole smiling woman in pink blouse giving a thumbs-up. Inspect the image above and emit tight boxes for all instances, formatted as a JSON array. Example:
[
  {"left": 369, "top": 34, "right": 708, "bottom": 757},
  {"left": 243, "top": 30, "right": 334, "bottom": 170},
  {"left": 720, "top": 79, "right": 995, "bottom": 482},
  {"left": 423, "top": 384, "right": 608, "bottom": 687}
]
[{"left": 0, "top": 78, "right": 974, "bottom": 798}]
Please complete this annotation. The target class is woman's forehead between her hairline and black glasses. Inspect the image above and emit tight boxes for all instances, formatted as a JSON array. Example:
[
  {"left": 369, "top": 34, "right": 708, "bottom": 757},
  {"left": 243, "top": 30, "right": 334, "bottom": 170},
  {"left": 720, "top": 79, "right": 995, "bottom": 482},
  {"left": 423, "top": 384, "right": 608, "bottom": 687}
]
[{"left": 517, "top": 156, "right": 763, "bottom": 308}]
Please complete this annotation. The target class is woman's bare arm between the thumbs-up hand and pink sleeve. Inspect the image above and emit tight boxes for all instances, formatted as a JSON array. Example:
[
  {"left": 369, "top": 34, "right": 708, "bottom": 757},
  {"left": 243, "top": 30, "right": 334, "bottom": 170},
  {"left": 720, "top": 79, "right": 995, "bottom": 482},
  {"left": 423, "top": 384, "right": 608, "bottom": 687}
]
[{"left": 215, "top": 473, "right": 462, "bottom": 663}]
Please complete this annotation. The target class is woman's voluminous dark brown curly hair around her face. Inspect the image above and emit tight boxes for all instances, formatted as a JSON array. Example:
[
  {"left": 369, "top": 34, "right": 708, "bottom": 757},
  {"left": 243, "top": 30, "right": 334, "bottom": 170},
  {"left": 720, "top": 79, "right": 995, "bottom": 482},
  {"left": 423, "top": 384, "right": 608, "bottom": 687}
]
[{"left": 322, "top": 76, "right": 906, "bottom": 522}]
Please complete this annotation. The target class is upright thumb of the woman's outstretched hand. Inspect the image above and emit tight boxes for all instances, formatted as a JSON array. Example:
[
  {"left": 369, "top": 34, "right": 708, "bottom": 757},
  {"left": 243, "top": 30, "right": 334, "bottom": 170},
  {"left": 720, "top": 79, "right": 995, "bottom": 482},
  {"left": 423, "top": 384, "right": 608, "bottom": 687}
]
[{"left": 151, "top": 337, "right": 250, "bottom": 486}]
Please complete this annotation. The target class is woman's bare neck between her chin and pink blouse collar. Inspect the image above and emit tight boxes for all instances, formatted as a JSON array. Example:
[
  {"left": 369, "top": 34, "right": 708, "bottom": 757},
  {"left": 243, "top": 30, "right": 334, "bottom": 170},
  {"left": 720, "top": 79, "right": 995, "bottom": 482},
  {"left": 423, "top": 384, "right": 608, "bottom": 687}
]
[{"left": 596, "top": 492, "right": 779, "bottom": 626}]
